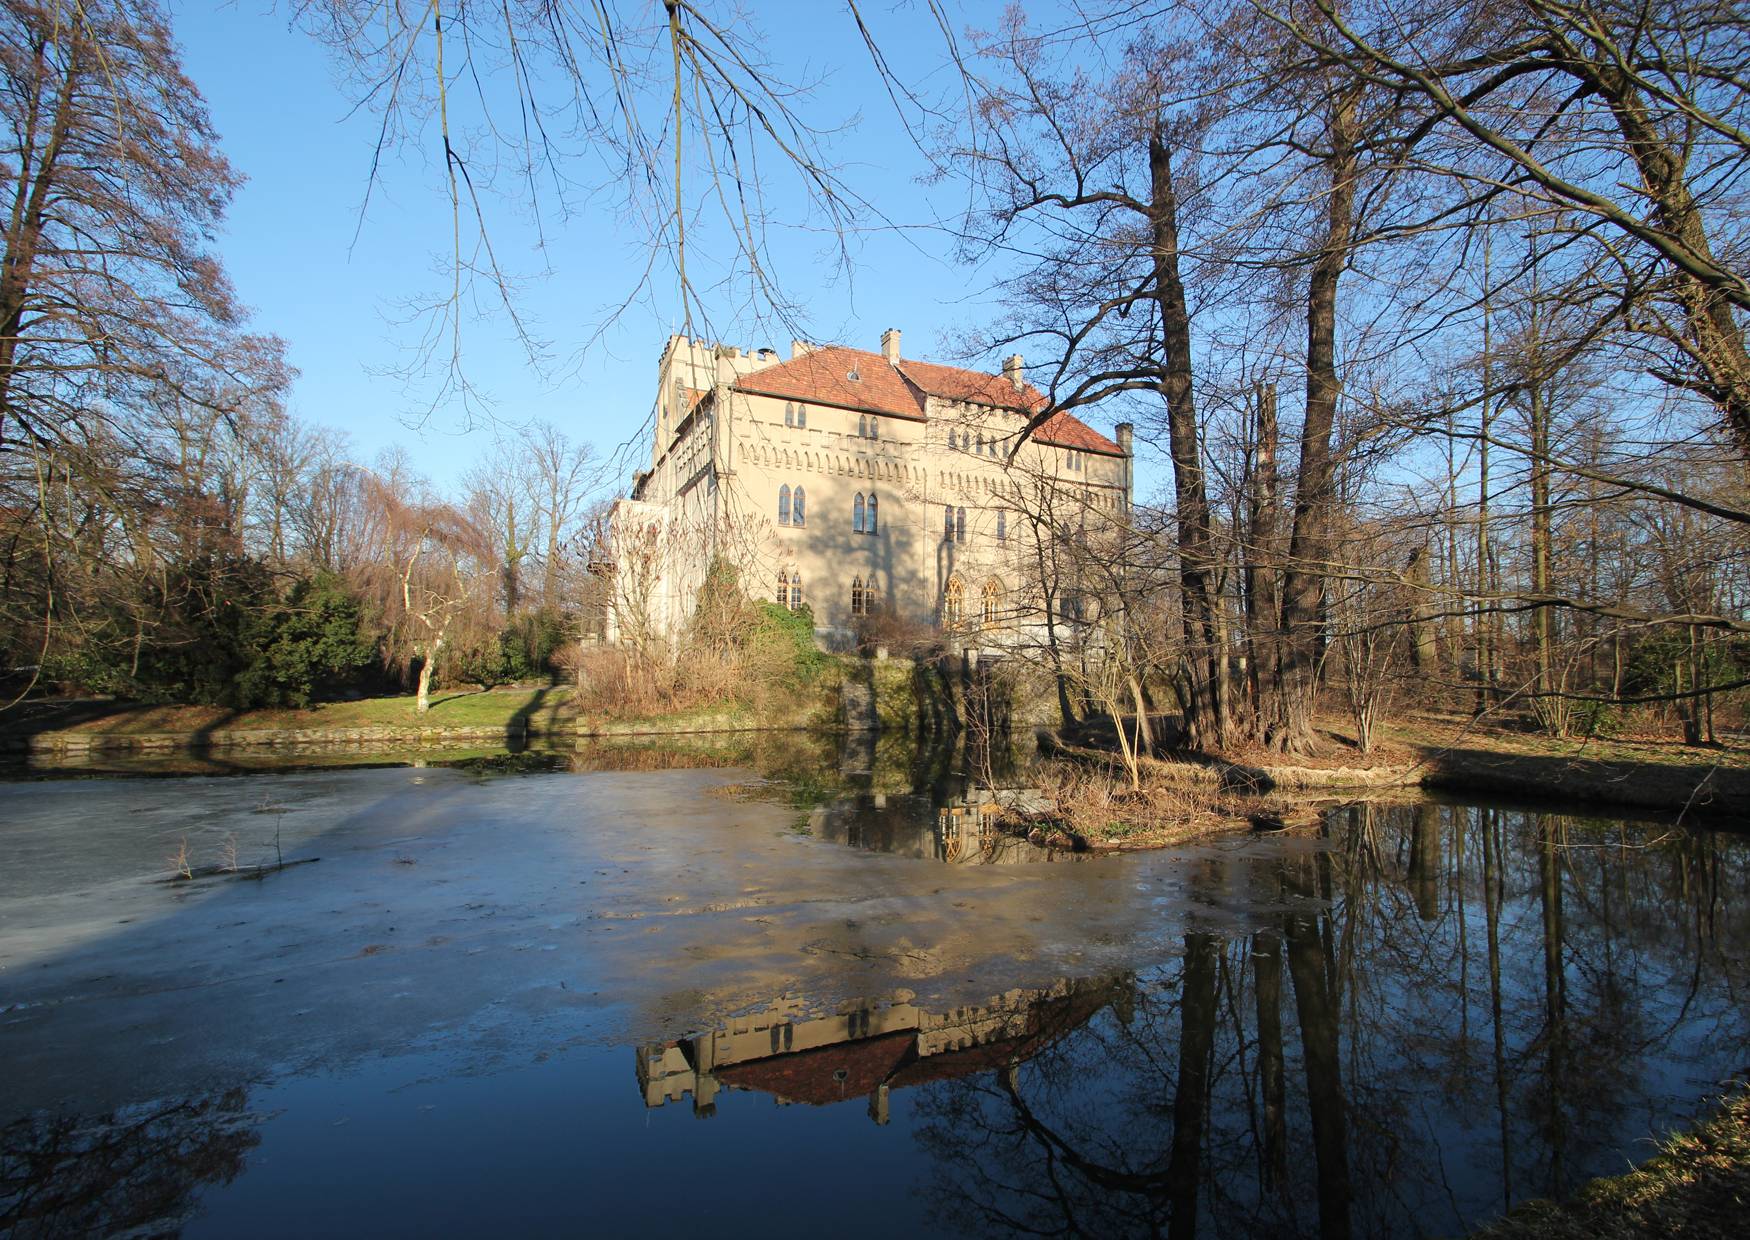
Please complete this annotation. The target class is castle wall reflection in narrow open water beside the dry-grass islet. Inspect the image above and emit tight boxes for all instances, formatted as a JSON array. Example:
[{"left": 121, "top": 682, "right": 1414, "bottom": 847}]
[{"left": 809, "top": 792, "right": 1087, "bottom": 866}]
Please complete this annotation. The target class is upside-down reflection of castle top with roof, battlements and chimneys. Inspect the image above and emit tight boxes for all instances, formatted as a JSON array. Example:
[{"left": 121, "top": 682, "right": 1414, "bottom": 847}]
[{"left": 637, "top": 978, "right": 1132, "bottom": 1123}]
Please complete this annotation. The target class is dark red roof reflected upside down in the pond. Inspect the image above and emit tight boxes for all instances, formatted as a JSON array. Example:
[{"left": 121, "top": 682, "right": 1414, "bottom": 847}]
[{"left": 716, "top": 990, "right": 1111, "bottom": 1107}]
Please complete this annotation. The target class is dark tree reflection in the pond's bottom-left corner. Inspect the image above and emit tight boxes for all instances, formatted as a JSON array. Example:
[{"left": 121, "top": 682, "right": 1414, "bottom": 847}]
[{"left": 0, "top": 1090, "right": 261, "bottom": 1237}]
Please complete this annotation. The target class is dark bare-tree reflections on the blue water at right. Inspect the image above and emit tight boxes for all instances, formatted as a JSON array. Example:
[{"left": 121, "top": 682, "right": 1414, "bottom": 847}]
[{"left": 919, "top": 806, "right": 1750, "bottom": 1237}]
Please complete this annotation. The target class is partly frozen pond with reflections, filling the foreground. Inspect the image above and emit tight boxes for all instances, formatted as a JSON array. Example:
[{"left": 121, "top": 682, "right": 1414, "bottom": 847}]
[{"left": 0, "top": 740, "right": 1750, "bottom": 1237}]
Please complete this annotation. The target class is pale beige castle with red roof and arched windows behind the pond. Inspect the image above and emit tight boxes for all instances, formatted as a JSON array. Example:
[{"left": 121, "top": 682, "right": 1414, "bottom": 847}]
[{"left": 611, "top": 329, "right": 1132, "bottom": 647}]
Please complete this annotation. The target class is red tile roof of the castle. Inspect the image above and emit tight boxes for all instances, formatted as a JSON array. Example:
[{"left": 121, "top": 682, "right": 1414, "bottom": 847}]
[{"left": 735, "top": 345, "right": 1124, "bottom": 456}]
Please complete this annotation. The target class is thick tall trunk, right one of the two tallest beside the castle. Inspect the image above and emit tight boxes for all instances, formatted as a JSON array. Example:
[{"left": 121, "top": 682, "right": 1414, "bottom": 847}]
[{"left": 1269, "top": 87, "right": 1356, "bottom": 752}]
